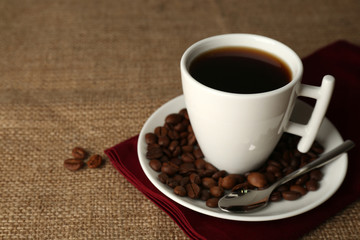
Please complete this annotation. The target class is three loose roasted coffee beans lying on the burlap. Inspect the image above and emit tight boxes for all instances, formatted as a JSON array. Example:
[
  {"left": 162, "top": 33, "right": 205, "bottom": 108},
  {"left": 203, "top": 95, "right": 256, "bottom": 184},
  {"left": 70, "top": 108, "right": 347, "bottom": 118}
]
[{"left": 64, "top": 147, "right": 102, "bottom": 171}]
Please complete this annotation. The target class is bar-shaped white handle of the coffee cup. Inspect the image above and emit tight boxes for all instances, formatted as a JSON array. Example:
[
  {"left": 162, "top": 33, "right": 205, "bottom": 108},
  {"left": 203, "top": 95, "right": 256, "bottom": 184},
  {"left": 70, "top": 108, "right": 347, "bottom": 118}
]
[{"left": 285, "top": 75, "right": 335, "bottom": 153}]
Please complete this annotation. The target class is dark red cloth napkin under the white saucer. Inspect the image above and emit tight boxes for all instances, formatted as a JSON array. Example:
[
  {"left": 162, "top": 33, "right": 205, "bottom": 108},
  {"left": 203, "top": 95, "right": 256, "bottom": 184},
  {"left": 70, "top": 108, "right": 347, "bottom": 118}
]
[{"left": 105, "top": 41, "right": 360, "bottom": 240}]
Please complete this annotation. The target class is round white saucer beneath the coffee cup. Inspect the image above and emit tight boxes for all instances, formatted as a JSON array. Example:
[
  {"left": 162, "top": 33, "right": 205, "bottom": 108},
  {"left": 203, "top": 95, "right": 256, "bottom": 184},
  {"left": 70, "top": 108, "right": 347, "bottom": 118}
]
[{"left": 138, "top": 95, "right": 348, "bottom": 221}]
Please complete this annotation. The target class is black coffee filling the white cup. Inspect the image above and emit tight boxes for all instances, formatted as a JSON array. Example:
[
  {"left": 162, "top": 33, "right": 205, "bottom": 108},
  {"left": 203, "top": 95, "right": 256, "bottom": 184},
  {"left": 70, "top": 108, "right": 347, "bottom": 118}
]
[{"left": 189, "top": 47, "right": 291, "bottom": 93}]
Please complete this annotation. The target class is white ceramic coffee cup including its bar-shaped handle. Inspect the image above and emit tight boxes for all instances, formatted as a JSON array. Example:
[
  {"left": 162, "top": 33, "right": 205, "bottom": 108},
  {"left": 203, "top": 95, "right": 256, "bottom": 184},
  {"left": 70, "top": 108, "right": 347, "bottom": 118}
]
[{"left": 180, "top": 34, "right": 335, "bottom": 173}]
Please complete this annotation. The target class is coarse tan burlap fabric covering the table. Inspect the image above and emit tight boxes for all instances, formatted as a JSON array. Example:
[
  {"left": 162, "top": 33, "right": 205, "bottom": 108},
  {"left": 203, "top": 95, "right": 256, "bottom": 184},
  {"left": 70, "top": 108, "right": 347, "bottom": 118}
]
[{"left": 0, "top": 0, "right": 360, "bottom": 239}]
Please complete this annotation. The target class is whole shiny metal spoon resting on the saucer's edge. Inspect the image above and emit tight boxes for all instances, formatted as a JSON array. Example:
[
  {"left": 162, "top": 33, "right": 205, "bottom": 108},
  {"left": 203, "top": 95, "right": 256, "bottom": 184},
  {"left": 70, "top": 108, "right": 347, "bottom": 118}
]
[{"left": 218, "top": 140, "right": 355, "bottom": 213}]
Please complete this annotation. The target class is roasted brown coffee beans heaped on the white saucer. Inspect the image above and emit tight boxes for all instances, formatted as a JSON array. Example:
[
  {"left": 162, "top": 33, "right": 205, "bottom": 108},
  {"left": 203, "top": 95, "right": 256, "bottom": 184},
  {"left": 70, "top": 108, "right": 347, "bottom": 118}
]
[{"left": 145, "top": 109, "right": 324, "bottom": 208}]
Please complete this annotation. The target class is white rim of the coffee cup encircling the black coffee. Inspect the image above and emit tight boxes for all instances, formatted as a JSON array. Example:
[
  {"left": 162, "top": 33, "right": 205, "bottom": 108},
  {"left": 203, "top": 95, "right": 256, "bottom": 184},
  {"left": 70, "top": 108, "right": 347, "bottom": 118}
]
[{"left": 180, "top": 33, "right": 303, "bottom": 98}]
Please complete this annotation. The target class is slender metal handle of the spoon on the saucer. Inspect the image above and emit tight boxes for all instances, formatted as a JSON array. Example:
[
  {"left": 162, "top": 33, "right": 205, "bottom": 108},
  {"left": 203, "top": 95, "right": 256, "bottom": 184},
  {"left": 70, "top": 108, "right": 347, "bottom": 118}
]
[{"left": 273, "top": 140, "right": 355, "bottom": 186}]
